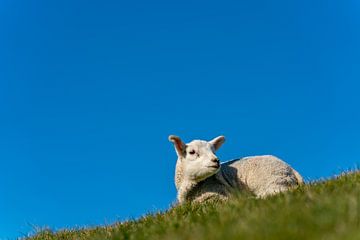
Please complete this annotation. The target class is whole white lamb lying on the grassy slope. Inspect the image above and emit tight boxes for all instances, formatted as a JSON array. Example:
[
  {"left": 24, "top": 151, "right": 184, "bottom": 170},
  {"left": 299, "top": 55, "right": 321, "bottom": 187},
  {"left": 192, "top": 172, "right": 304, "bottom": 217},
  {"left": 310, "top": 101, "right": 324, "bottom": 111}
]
[{"left": 169, "top": 135, "right": 304, "bottom": 204}]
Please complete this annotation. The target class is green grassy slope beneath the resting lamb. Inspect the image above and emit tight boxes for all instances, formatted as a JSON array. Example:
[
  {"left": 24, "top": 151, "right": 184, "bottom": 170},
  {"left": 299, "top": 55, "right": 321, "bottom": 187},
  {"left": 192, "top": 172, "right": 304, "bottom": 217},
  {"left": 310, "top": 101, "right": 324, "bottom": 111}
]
[{"left": 27, "top": 172, "right": 360, "bottom": 240}]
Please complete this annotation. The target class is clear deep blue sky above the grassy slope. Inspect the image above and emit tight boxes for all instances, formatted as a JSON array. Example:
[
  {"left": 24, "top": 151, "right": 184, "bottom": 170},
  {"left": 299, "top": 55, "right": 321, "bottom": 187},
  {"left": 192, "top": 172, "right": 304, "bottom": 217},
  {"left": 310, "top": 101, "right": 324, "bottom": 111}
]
[{"left": 0, "top": 0, "right": 360, "bottom": 238}]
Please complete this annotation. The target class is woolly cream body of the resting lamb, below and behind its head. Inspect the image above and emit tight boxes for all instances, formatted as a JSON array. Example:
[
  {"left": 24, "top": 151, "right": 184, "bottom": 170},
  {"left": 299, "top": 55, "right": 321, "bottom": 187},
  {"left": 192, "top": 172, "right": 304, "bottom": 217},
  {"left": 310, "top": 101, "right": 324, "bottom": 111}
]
[{"left": 178, "top": 155, "right": 303, "bottom": 202}]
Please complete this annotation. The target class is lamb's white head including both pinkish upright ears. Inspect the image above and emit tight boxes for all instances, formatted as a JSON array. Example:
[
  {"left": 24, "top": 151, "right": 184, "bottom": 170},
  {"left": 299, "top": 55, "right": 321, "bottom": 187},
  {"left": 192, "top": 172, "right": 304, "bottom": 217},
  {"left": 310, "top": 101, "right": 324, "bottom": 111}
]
[{"left": 169, "top": 135, "right": 225, "bottom": 184}]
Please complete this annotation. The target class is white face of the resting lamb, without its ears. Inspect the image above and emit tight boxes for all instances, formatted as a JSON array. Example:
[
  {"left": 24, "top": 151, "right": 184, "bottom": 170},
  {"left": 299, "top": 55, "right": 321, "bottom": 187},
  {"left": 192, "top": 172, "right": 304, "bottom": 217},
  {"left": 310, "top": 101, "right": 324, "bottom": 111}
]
[{"left": 181, "top": 140, "right": 220, "bottom": 182}]
